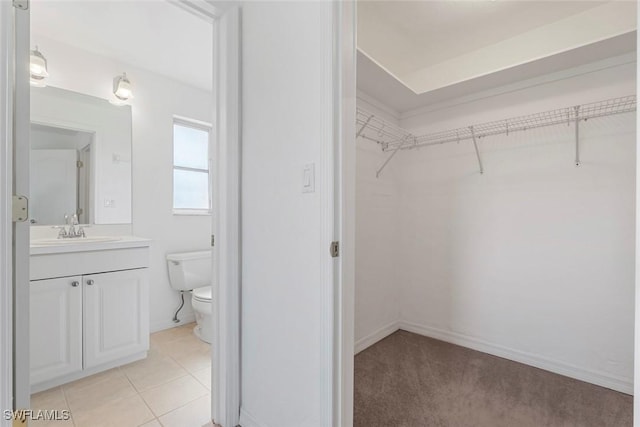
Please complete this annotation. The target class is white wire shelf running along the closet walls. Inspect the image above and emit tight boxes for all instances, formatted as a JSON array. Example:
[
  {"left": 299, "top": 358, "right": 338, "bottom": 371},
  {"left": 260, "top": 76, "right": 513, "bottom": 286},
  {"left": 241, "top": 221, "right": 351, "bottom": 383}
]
[{"left": 356, "top": 95, "right": 636, "bottom": 151}]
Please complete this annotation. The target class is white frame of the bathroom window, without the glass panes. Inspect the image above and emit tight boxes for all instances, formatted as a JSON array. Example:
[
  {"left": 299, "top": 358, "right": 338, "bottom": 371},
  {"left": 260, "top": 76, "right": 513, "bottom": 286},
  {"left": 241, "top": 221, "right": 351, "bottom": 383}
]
[{"left": 171, "top": 115, "right": 213, "bottom": 216}]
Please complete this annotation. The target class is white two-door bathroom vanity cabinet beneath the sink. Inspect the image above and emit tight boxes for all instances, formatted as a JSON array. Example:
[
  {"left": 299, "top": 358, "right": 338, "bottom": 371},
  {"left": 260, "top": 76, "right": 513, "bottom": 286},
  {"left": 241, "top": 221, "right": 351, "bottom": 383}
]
[{"left": 29, "top": 238, "right": 149, "bottom": 392}]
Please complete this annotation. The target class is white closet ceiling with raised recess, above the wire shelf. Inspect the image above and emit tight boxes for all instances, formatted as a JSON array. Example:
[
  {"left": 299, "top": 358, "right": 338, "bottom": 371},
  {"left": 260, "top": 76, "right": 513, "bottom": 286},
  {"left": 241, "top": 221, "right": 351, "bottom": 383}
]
[{"left": 358, "top": 0, "right": 637, "bottom": 112}]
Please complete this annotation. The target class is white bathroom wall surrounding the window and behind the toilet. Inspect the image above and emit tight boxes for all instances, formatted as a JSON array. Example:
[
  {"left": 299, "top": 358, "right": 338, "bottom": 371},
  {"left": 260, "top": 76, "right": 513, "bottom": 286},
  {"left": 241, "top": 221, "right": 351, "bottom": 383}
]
[{"left": 32, "top": 34, "right": 213, "bottom": 331}]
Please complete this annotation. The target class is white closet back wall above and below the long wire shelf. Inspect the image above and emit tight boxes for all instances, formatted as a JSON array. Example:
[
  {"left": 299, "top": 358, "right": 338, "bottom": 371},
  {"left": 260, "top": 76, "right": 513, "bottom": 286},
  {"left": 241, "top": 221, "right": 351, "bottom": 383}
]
[{"left": 380, "top": 63, "right": 636, "bottom": 393}]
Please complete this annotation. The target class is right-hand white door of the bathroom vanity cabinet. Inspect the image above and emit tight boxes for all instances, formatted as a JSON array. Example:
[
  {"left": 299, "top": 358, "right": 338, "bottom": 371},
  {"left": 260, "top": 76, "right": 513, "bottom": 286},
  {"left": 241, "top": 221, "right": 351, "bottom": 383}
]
[{"left": 82, "top": 268, "right": 149, "bottom": 368}]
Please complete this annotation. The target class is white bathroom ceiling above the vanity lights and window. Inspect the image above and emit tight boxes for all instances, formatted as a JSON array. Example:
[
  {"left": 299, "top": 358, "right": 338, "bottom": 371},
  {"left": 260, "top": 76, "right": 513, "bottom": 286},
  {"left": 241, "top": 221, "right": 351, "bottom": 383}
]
[{"left": 31, "top": 0, "right": 213, "bottom": 90}]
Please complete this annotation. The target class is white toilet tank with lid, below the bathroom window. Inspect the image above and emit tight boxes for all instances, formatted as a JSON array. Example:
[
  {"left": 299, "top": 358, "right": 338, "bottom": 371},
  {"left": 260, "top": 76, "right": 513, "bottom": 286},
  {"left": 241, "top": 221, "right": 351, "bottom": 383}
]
[{"left": 167, "top": 251, "right": 212, "bottom": 291}]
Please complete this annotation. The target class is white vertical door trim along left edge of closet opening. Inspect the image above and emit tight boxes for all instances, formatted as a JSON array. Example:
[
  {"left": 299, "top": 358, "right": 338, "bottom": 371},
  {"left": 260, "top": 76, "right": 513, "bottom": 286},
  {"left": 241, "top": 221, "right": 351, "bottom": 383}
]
[{"left": 336, "top": 1, "right": 357, "bottom": 427}]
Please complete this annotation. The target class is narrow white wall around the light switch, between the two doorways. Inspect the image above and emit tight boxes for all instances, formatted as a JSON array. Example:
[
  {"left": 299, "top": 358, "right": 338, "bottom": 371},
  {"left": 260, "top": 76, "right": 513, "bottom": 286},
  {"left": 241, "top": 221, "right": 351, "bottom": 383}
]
[{"left": 240, "top": 2, "right": 334, "bottom": 427}]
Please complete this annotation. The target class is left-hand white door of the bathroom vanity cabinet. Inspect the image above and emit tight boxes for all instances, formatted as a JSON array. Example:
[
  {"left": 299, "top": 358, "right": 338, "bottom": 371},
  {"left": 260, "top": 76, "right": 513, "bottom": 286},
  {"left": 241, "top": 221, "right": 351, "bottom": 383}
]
[{"left": 29, "top": 276, "right": 82, "bottom": 384}]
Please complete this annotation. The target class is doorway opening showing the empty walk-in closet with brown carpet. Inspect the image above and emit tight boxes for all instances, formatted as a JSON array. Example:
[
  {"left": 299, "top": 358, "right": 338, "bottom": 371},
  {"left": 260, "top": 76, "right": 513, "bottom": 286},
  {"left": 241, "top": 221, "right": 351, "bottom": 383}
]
[{"left": 354, "top": 2, "right": 637, "bottom": 426}]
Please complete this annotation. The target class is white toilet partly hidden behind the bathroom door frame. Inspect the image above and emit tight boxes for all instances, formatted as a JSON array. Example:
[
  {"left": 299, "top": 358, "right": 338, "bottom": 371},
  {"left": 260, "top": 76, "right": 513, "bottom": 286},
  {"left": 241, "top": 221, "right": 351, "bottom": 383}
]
[{"left": 167, "top": 251, "right": 213, "bottom": 343}]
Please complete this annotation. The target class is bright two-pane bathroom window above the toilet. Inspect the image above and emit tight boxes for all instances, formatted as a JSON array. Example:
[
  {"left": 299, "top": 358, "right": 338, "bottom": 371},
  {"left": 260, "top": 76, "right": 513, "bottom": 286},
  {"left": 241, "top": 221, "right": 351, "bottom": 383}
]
[{"left": 173, "top": 119, "right": 211, "bottom": 215}]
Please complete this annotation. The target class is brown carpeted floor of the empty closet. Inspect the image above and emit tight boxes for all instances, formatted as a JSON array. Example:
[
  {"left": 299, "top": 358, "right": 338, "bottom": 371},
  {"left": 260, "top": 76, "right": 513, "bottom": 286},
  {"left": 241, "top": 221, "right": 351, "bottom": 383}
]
[{"left": 354, "top": 331, "right": 633, "bottom": 427}]
